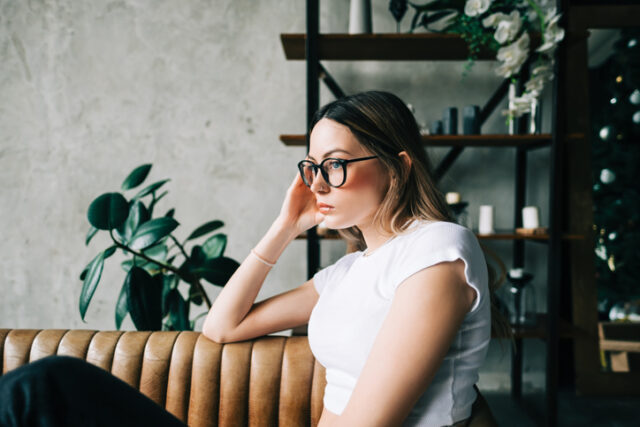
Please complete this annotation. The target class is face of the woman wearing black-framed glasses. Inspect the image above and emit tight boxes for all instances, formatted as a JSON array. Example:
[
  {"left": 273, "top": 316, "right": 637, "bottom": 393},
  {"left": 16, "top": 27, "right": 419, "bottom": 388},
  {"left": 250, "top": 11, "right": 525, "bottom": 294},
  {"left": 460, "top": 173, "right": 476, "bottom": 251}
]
[{"left": 307, "top": 118, "right": 389, "bottom": 229}]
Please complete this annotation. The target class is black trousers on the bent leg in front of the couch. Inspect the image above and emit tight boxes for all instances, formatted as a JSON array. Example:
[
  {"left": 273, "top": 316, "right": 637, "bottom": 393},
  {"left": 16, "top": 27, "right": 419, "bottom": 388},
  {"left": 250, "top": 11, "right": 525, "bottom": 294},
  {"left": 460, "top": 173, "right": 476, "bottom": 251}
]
[{"left": 0, "top": 356, "right": 185, "bottom": 427}]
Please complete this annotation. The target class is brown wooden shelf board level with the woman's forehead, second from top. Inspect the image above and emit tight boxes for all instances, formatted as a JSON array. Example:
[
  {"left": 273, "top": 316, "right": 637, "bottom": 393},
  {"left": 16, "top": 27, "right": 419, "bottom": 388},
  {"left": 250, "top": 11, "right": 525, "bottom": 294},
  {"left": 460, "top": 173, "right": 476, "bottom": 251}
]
[{"left": 280, "top": 133, "right": 584, "bottom": 148}]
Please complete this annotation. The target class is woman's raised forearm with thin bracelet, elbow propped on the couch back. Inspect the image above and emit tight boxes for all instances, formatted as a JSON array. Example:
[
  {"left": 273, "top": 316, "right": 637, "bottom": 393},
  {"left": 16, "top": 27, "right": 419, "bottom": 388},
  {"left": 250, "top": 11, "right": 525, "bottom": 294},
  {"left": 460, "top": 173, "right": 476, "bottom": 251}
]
[{"left": 203, "top": 219, "right": 297, "bottom": 340}]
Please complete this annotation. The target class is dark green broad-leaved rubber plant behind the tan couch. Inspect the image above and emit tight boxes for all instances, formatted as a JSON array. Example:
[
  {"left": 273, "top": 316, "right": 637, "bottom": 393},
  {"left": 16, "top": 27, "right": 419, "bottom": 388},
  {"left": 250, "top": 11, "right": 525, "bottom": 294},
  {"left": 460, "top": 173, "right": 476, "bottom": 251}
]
[{"left": 79, "top": 164, "right": 239, "bottom": 330}]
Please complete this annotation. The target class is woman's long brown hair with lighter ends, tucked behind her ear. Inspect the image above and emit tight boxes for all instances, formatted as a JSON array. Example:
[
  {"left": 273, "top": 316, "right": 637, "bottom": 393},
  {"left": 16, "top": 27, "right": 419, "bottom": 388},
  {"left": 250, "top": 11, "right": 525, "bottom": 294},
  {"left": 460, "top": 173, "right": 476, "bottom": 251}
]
[{"left": 310, "top": 91, "right": 510, "bottom": 335}]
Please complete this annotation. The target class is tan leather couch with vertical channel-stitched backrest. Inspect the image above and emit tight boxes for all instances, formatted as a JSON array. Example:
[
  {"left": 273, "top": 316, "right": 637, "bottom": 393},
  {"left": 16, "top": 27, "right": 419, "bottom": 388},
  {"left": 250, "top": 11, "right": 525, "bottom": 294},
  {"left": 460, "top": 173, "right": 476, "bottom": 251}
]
[{"left": 0, "top": 329, "right": 495, "bottom": 427}]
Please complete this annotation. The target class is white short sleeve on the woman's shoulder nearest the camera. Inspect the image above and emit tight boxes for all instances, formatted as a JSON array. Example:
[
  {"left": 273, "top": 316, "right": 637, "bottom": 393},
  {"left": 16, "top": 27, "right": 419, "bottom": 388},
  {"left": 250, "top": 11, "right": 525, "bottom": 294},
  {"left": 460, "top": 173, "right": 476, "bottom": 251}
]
[{"left": 390, "top": 222, "right": 488, "bottom": 312}]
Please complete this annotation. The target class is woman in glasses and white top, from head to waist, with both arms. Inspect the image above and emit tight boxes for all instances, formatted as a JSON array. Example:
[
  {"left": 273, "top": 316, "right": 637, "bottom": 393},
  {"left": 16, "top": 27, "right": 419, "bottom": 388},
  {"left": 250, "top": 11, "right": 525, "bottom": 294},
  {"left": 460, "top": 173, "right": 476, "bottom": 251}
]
[{"left": 203, "top": 92, "right": 491, "bottom": 426}]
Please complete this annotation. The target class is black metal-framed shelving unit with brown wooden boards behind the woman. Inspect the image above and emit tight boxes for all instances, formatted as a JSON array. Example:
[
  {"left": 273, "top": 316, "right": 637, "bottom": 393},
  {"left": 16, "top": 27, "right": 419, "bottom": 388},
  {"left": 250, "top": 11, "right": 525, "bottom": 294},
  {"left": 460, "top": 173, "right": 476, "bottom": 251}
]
[{"left": 280, "top": 0, "right": 572, "bottom": 426}]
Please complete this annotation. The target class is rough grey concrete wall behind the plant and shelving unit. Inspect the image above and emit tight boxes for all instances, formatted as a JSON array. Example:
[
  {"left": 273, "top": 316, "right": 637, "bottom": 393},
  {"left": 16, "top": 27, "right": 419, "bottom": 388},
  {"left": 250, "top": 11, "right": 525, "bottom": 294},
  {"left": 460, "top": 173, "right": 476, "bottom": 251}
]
[{"left": 0, "top": 0, "right": 549, "bottom": 388}]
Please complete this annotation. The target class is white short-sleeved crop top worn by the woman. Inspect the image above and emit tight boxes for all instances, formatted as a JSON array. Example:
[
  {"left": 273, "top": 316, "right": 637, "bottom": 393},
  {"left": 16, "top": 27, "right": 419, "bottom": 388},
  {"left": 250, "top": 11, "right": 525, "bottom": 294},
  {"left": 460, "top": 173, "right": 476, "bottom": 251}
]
[{"left": 308, "top": 221, "right": 491, "bottom": 427}]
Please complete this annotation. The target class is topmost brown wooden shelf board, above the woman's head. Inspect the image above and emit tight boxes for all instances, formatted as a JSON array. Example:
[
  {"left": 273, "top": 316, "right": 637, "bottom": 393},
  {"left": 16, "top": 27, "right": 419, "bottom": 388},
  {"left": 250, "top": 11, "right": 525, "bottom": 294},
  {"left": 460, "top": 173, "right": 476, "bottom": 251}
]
[{"left": 280, "top": 33, "right": 495, "bottom": 61}]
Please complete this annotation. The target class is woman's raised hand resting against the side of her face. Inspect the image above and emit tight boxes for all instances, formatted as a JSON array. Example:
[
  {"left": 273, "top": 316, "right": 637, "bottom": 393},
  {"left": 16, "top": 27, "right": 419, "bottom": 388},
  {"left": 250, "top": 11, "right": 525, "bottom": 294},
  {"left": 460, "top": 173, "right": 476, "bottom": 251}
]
[{"left": 279, "top": 174, "right": 324, "bottom": 235}]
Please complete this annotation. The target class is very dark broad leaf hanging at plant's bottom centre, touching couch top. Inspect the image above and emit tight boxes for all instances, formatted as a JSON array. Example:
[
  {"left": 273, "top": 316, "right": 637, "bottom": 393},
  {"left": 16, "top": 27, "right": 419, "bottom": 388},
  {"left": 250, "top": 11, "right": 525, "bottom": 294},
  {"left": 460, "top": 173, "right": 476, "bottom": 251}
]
[{"left": 125, "top": 267, "right": 162, "bottom": 331}]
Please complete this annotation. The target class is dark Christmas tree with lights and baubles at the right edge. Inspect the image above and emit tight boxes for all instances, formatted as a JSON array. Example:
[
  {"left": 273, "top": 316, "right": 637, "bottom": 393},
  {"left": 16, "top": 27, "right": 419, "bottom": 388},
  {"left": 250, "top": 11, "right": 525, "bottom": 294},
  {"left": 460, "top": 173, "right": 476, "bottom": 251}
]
[{"left": 589, "top": 29, "right": 640, "bottom": 315}]
